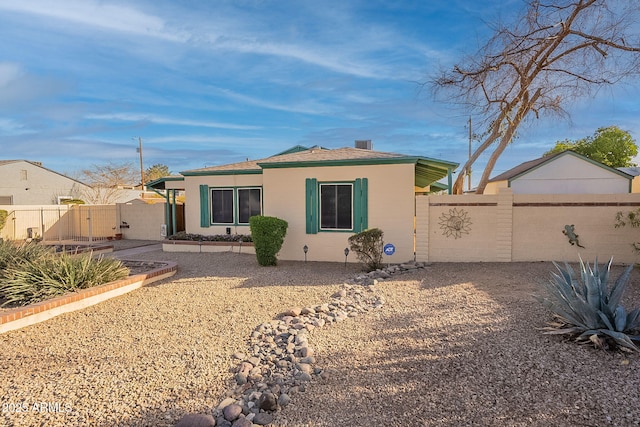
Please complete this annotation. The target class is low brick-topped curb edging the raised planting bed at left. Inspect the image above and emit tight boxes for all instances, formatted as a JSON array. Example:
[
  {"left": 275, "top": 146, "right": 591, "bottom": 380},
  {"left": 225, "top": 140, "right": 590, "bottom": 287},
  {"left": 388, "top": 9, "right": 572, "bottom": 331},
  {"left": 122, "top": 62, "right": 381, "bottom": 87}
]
[{"left": 0, "top": 261, "right": 178, "bottom": 334}]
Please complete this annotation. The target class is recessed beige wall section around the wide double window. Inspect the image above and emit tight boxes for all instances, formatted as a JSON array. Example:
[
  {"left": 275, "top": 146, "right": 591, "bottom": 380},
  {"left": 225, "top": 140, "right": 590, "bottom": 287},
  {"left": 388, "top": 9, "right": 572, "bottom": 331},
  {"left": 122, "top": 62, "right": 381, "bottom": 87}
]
[{"left": 184, "top": 174, "right": 265, "bottom": 236}]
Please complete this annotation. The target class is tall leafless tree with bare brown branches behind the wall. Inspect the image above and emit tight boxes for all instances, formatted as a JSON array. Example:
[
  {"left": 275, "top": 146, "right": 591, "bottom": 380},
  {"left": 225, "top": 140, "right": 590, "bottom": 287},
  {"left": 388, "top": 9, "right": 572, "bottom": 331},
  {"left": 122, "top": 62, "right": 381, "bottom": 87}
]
[{"left": 433, "top": 0, "right": 640, "bottom": 194}]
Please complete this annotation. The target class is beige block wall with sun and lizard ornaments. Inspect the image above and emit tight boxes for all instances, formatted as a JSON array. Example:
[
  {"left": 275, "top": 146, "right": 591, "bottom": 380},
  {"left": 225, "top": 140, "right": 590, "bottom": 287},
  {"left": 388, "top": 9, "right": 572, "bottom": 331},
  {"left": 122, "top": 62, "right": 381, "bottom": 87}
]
[{"left": 416, "top": 188, "right": 640, "bottom": 263}]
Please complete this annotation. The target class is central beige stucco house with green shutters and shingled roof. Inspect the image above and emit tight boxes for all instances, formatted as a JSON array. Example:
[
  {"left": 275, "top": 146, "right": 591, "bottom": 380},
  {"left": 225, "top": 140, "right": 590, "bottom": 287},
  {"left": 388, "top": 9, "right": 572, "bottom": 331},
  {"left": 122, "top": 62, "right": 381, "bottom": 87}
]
[{"left": 152, "top": 147, "right": 458, "bottom": 261}]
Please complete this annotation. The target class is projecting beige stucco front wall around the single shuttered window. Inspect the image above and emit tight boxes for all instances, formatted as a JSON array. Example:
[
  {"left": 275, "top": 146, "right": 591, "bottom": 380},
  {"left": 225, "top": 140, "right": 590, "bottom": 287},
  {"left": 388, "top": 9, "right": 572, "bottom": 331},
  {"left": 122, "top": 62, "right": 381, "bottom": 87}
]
[{"left": 263, "top": 164, "right": 414, "bottom": 262}]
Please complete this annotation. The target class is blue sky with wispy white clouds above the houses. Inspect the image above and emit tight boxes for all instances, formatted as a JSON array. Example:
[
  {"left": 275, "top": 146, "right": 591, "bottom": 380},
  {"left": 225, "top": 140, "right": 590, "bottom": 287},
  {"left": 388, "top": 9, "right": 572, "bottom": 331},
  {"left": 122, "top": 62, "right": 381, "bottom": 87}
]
[{"left": 0, "top": 0, "right": 640, "bottom": 184}]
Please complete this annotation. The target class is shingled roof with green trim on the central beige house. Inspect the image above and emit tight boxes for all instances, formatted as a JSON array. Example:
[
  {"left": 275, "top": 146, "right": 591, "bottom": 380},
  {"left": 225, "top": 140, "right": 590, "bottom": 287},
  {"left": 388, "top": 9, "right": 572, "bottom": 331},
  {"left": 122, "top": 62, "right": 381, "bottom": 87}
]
[{"left": 180, "top": 146, "right": 458, "bottom": 187}]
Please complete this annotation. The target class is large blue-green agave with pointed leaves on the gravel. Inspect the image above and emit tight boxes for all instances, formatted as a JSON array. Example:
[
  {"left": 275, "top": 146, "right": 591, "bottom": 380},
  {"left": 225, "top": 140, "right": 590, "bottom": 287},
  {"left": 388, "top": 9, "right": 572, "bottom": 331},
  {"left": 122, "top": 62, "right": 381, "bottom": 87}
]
[{"left": 536, "top": 258, "right": 640, "bottom": 351}]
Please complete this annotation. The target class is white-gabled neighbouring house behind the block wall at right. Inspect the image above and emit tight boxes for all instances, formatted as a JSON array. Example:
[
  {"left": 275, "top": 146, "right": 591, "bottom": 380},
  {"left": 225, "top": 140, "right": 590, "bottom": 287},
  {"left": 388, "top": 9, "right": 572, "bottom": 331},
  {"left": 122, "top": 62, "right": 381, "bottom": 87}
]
[{"left": 484, "top": 151, "right": 632, "bottom": 194}]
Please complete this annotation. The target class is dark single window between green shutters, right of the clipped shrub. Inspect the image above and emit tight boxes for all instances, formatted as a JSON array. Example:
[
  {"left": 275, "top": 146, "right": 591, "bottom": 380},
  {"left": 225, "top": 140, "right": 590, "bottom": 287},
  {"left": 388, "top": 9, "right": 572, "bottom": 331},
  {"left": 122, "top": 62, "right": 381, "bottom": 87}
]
[{"left": 320, "top": 184, "right": 353, "bottom": 230}]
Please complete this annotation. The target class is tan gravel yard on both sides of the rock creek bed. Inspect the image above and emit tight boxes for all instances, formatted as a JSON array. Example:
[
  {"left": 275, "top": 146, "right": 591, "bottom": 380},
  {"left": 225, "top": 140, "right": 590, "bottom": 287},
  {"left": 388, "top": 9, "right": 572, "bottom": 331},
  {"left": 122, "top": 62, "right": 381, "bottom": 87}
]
[{"left": 0, "top": 247, "right": 640, "bottom": 427}]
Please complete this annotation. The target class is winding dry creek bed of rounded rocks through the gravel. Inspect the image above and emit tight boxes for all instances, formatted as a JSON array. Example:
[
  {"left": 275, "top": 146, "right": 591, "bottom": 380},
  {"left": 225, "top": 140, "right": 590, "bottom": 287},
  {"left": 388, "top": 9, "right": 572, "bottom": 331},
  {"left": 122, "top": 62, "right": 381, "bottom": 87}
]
[{"left": 176, "top": 261, "right": 428, "bottom": 427}]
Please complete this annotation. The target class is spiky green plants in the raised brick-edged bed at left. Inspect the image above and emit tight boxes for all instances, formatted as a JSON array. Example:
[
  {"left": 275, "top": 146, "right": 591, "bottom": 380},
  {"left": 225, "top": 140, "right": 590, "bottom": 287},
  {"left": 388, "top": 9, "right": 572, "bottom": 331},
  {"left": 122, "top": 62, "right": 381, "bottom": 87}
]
[{"left": 0, "top": 243, "right": 129, "bottom": 305}]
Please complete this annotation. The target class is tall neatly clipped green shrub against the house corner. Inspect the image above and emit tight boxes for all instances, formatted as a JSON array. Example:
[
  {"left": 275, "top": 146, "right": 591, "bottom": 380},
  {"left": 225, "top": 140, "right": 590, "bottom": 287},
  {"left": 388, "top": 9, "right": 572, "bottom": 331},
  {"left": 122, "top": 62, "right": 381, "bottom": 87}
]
[{"left": 249, "top": 215, "right": 289, "bottom": 266}]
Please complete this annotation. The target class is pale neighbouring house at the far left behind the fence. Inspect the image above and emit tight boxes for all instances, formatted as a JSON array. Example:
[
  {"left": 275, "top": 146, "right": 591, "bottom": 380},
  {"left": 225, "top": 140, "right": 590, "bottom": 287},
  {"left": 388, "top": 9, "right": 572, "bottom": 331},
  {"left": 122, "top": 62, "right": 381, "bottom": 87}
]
[{"left": 0, "top": 160, "right": 91, "bottom": 205}]
